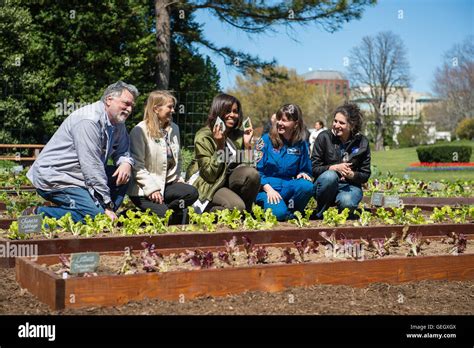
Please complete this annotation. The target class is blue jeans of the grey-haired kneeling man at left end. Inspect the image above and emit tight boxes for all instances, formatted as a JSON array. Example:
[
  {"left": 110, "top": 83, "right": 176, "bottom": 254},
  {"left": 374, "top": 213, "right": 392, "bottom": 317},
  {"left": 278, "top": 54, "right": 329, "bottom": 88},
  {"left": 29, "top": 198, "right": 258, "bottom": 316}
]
[{"left": 36, "top": 166, "right": 128, "bottom": 222}]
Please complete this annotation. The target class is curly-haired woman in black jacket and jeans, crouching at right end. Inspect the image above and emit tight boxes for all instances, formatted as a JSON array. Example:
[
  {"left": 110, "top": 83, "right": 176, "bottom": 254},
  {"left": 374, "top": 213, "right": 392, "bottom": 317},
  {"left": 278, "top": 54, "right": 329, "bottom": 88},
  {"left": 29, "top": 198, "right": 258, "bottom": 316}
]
[{"left": 311, "top": 104, "right": 370, "bottom": 219}]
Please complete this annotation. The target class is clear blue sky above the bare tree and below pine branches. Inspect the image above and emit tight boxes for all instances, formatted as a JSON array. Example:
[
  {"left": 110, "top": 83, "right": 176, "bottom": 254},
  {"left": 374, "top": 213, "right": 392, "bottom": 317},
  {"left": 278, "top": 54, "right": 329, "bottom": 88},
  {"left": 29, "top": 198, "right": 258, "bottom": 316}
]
[{"left": 196, "top": 0, "right": 474, "bottom": 92}]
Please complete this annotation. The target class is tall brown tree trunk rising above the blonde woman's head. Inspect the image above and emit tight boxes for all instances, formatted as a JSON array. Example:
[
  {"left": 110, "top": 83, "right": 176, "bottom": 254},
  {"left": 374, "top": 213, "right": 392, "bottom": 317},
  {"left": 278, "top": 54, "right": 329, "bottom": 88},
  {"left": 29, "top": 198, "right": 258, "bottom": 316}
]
[{"left": 155, "top": 0, "right": 171, "bottom": 89}]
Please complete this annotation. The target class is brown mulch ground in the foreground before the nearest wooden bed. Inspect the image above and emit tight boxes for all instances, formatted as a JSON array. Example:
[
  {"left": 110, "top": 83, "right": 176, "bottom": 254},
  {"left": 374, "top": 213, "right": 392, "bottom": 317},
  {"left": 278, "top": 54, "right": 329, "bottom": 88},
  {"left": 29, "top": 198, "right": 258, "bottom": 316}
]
[{"left": 0, "top": 269, "right": 474, "bottom": 315}]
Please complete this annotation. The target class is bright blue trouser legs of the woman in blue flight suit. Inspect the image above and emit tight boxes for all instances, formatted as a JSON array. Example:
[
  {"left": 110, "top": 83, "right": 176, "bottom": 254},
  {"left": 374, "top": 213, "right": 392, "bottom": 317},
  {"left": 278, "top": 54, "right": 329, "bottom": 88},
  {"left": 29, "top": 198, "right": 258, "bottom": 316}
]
[{"left": 256, "top": 178, "right": 313, "bottom": 221}]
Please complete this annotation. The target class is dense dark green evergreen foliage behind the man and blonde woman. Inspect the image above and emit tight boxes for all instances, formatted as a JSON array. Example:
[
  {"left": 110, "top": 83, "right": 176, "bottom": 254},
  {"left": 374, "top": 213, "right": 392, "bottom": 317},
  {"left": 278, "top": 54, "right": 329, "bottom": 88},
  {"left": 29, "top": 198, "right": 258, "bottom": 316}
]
[{"left": 0, "top": 0, "right": 219, "bottom": 143}]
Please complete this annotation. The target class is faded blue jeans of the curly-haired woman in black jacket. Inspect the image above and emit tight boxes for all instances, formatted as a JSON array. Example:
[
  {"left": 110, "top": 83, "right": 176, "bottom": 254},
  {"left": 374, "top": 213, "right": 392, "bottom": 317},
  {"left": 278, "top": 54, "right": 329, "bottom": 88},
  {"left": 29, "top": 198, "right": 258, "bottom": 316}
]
[{"left": 314, "top": 170, "right": 362, "bottom": 219}]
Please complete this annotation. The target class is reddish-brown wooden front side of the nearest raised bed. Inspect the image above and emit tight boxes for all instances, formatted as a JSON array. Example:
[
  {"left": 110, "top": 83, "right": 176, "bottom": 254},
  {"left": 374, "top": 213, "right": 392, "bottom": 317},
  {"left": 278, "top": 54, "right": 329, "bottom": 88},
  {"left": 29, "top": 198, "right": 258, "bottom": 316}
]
[{"left": 17, "top": 254, "right": 474, "bottom": 308}]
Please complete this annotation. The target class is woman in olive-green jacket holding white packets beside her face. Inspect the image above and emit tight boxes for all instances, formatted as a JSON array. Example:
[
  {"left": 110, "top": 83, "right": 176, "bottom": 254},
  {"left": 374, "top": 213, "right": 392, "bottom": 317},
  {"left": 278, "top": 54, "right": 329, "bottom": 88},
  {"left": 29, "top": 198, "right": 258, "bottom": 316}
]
[{"left": 186, "top": 94, "right": 260, "bottom": 212}]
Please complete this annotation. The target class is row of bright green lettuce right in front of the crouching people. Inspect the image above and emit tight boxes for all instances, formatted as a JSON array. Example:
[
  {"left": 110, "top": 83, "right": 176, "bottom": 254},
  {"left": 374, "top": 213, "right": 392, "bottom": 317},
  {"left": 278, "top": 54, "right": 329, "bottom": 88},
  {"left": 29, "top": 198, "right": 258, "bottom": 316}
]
[{"left": 6, "top": 205, "right": 474, "bottom": 239}]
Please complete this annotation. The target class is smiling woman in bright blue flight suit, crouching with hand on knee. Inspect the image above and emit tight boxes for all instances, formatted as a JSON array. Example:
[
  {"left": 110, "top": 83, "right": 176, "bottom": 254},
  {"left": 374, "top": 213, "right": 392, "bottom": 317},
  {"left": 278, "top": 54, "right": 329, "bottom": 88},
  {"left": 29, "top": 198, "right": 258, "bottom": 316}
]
[{"left": 255, "top": 104, "right": 313, "bottom": 221}]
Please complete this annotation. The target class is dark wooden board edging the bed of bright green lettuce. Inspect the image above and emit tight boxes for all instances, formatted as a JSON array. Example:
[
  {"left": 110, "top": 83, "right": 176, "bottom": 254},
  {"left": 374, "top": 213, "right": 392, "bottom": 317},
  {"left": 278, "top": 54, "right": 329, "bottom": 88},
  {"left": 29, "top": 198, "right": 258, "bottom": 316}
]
[{"left": 0, "top": 223, "right": 474, "bottom": 267}]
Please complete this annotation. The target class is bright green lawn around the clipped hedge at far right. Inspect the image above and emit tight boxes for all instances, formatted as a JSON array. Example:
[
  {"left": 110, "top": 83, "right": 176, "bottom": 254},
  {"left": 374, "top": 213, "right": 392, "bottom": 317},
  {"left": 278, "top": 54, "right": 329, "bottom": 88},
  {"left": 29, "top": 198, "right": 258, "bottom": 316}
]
[{"left": 372, "top": 141, "right": 474, "bottom": 180}]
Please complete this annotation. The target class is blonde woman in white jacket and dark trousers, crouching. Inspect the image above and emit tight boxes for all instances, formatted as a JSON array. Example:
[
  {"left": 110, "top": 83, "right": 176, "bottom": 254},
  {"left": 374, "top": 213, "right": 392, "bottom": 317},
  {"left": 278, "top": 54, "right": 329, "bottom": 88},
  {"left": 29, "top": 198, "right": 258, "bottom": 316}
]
[{"left": 128, "top": 91, "right": 198, "bottom": 223}]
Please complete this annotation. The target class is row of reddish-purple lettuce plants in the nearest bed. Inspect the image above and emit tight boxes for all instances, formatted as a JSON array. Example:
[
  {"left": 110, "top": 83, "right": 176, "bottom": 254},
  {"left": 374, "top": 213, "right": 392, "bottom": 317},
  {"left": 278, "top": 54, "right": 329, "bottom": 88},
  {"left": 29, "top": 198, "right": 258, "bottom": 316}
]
[{"left": 53, "top": 228, "right": 468, "bottom": 277}]
